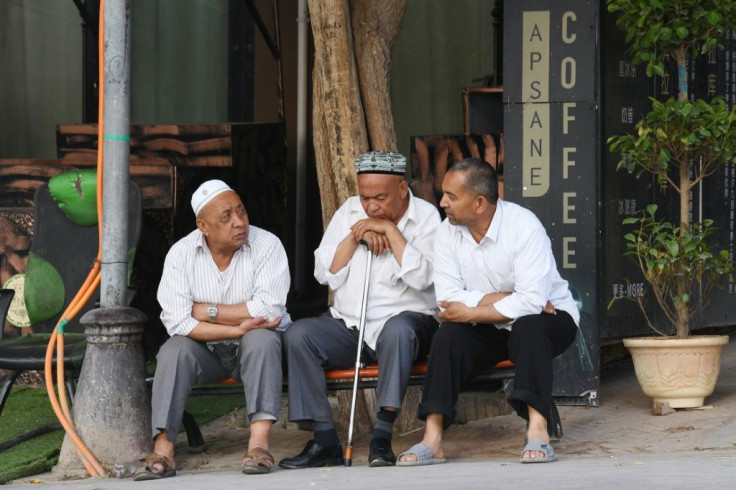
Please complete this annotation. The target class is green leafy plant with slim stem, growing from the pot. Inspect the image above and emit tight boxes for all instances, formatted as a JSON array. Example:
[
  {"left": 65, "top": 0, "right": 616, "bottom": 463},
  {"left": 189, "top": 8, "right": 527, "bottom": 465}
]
[{"left": 607, "top": 0, "right": 736, "bottom": 337}]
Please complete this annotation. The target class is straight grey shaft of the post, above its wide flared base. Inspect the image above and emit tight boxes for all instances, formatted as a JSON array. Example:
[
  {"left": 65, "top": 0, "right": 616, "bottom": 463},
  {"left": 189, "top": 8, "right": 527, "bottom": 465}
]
[{"left": 100, "top": 0, "right": 130, "bottom": 308}]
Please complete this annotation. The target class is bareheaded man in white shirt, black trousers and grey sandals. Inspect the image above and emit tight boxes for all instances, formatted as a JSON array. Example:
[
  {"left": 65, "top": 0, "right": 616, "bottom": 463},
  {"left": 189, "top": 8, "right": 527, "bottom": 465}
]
[{"left": 398, "top": 158, "right": 580, "bottom": 466}]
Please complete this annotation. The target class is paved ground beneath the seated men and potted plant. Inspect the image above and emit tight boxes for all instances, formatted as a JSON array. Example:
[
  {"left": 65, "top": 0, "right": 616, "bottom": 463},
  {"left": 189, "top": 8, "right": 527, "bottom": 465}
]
[{"left": 7, "top": 338, "right": 736, "bottom": 490}]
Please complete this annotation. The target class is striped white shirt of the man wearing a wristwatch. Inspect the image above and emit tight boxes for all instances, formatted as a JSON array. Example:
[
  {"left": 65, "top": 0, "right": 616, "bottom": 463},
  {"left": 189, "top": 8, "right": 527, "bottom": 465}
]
[{"left": 157, "top": 226, "right": 291, "bottom": 342}]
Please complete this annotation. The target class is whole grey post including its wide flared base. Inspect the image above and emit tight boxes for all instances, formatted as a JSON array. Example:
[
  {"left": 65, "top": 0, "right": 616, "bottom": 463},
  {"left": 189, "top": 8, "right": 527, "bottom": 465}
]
[{"left": 57, "top": 0, "right": 152, "bottom": 473}]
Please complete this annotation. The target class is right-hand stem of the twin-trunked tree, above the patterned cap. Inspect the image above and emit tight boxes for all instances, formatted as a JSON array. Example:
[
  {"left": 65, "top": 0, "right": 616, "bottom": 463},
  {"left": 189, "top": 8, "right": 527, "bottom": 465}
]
[{"left": 351, "top": 0, "right": 406, "bottom": 151}]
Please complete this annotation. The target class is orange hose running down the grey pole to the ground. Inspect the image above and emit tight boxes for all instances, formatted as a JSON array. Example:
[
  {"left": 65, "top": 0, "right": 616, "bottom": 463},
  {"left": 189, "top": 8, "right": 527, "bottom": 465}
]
[{"left": 44, "top": 0, "right": 105, "bottom": 476}]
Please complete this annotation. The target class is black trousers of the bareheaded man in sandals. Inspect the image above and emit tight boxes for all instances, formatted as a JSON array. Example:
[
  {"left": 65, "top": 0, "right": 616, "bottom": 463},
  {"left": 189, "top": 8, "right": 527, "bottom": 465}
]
[{"left": 419, "top": 310, "right": 578, "bottom": 429}]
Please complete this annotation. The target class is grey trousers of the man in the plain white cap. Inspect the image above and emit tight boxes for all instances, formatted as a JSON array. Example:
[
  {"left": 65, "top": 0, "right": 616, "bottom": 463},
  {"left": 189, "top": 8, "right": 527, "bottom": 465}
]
[{"left": 151, "top": 328, "right": 283, "bottom": 440}]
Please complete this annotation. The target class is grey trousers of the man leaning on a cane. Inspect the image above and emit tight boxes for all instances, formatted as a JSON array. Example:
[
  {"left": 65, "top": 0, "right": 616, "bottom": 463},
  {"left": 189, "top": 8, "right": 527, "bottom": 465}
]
[{"left": 284, "top": 311, "right": 437, "bottom": 422}]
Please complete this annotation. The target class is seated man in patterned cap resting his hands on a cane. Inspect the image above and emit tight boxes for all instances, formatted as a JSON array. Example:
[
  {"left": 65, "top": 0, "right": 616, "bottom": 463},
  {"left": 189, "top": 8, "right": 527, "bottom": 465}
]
[{"left": 279, "top": 152, "right": 440, "bottom": 469}]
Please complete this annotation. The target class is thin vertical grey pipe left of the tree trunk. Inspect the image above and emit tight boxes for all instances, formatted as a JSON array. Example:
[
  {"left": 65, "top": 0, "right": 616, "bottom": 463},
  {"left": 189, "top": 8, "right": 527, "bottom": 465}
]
[{"left": 294, "top": 0, "right": 309, "bottom": 294}]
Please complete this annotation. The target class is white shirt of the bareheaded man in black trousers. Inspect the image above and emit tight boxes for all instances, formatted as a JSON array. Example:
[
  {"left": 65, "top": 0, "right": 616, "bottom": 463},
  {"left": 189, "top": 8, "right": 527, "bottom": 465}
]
[{"left": 434, "top": 199, "right": 580, "bottom": 327}]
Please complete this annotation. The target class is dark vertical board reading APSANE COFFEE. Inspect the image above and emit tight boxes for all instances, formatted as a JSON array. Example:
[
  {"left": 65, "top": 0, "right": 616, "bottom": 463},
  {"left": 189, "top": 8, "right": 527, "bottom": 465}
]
[{"left": 504, "top": 0, "right": 599, "bottom": 404}]
